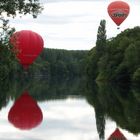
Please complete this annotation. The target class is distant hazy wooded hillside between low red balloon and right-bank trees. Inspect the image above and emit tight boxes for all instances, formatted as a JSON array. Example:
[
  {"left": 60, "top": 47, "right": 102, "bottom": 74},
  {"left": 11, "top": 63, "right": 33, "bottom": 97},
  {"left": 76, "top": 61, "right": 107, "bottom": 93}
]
[{"left": 29, "top": 48, "right": 87, "bottom": 78}]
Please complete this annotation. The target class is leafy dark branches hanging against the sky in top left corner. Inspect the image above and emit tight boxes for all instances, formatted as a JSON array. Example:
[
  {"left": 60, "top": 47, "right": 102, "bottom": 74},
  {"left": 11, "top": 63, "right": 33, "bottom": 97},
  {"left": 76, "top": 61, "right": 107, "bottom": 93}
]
[{"left": 0, "top": 0, "right": 42, "bottom": 18}]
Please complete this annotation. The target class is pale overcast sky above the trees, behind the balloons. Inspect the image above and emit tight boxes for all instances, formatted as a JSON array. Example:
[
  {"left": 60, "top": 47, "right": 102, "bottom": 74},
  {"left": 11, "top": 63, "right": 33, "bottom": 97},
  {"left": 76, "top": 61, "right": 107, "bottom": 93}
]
[{"left": 10, "top": 0, "right": 140, "bottom": 50}]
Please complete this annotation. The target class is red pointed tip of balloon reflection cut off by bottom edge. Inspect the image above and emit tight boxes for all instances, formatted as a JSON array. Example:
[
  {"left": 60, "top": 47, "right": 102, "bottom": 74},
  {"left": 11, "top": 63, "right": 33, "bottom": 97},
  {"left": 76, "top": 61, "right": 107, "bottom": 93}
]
[{"left": 108, "top": 128, "right": 127, "bottom": 140}]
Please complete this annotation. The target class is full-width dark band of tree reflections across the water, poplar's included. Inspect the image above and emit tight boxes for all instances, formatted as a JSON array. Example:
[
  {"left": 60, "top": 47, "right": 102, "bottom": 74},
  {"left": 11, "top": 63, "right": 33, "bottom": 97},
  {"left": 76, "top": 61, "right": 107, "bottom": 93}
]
[{"left": 0, "top": 78, "right": 140, "bottom": 137}]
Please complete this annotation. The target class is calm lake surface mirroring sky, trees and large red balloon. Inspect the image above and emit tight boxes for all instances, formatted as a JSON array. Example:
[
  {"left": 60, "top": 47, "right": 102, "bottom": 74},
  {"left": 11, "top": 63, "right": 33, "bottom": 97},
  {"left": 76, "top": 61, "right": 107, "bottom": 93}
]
[{"left": 0, "top": 79, "right": 140, "bottom": 140}]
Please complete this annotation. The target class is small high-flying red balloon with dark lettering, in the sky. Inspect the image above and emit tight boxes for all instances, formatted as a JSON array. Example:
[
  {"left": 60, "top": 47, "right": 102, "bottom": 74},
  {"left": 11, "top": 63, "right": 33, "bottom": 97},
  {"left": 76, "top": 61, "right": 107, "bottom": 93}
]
[{"left": 108, "top": 1, "right": 130, "bottom": 26}]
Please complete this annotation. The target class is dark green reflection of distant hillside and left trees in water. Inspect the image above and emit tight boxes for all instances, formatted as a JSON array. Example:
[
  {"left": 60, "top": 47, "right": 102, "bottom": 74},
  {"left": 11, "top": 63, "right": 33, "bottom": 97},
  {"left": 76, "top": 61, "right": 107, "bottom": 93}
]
[{"left": 0, "top": 73, "right": 85, "bottom": 110}]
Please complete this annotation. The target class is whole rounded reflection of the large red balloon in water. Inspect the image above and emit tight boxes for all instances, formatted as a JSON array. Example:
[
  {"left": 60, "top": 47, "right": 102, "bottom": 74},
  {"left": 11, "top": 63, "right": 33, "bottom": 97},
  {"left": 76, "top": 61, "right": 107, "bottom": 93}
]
[{"left": 8, "top": 91, "right": 43, "bottom": 130}]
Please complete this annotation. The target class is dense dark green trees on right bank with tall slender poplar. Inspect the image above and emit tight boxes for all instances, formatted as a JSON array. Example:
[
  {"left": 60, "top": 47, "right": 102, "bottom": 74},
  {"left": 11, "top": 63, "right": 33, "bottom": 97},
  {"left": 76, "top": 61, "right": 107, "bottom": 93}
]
[{"left": 86, "top": 20, "right": 140, "bottom": 83}]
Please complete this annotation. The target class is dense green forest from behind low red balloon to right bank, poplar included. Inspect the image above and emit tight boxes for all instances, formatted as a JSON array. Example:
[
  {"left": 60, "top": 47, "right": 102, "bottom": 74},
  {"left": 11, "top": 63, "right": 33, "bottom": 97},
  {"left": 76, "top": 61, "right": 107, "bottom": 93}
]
[{"left": 10, "top": 20, "right": 140, "bottom": 84}]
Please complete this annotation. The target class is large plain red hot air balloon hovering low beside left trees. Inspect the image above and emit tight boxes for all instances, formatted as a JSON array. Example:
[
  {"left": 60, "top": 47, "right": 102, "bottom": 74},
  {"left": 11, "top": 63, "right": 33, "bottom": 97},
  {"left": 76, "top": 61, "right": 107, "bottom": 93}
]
[{"left": 10, "top": 30, "right": 44, "bottom": 69}]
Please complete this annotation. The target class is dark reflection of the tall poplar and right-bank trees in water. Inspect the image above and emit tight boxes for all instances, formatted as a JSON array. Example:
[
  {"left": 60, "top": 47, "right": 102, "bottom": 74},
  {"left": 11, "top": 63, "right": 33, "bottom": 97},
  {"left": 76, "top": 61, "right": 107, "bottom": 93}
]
[{"left": 85, "top": 82, "right": 140, "bottom": 140}]
